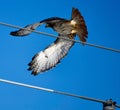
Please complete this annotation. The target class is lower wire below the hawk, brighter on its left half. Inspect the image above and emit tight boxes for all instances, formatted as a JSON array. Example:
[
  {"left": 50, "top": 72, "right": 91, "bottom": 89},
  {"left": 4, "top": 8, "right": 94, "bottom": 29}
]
[{"left": 0, "top": 79, "right": 120, "bottom": 108}]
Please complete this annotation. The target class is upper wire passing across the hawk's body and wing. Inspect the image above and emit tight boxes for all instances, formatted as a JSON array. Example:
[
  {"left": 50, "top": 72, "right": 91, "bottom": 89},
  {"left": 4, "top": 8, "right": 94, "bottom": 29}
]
[{"left": 0, "top": 22, "right": 120, "bottom": 53}]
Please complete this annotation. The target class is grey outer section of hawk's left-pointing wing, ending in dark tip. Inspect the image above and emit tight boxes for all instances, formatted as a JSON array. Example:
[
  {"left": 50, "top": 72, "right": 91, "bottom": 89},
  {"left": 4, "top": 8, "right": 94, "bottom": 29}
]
[{"left": 10, "top": 22, "right": 42, "bottom": 36}]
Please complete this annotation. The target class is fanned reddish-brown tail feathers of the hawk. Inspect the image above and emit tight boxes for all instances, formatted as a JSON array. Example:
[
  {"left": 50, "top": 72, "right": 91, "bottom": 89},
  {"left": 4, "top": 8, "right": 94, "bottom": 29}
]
[{"left": 71, "top": 8, "right": 88, "bottom": 42}]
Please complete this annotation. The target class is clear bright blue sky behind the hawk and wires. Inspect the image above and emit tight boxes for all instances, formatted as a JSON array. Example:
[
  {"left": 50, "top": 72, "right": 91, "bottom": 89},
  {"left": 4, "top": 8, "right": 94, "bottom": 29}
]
[{"left": 0, "top": 0, "right": 120, "bottom": 110}]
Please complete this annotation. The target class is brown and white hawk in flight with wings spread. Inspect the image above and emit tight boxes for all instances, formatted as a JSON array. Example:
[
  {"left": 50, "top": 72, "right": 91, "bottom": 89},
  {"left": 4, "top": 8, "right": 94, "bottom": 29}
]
[{"left": 10, "top": 8, "right": 88, "bottom": 75}]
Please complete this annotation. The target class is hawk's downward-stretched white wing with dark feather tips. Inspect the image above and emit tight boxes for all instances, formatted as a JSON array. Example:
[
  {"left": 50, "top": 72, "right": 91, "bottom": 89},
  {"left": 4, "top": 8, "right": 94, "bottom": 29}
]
[{"left": 28, "top": 36, "right": 74, "bottom": 75}]
